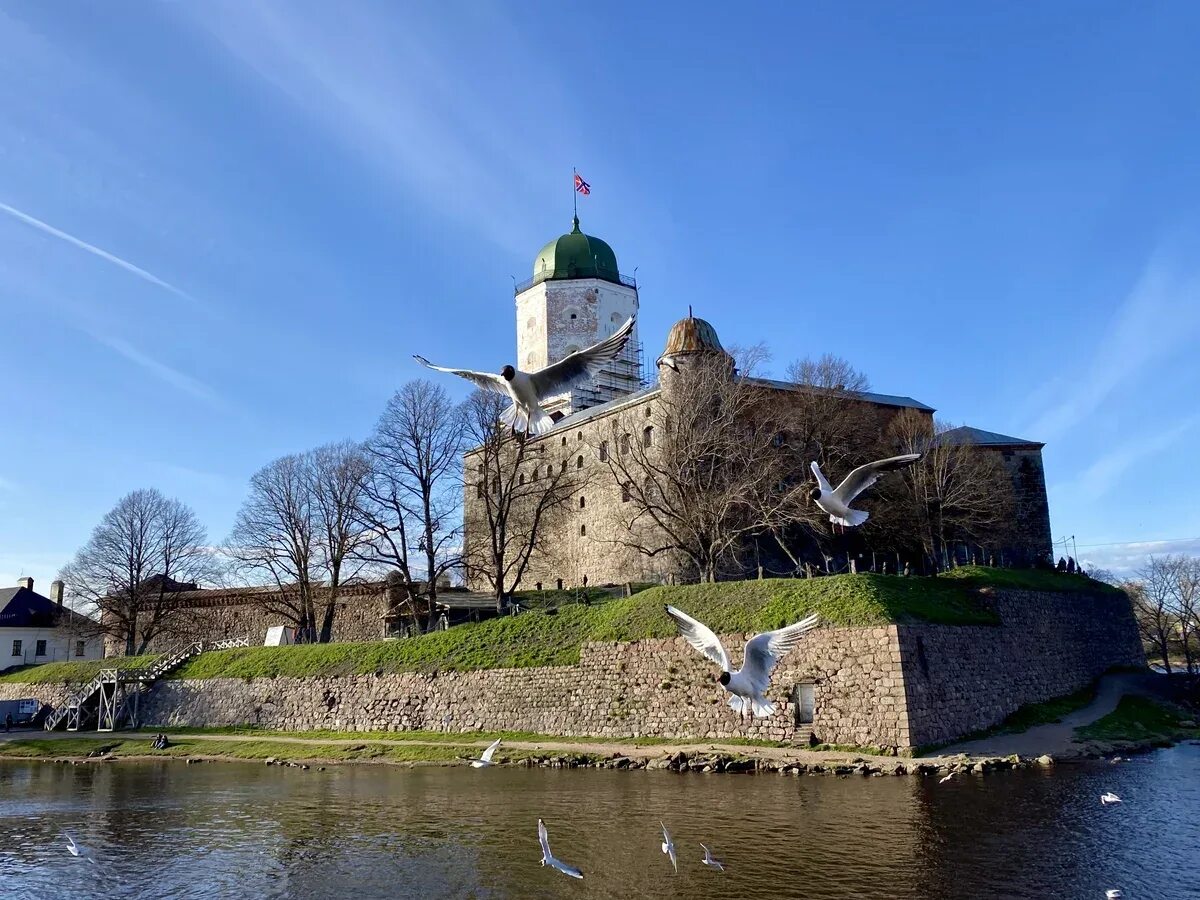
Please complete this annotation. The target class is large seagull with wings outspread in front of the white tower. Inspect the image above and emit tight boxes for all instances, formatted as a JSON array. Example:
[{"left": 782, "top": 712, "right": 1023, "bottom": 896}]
[{"left": 413, "top": 318, "right": 634, "bottom": 434}]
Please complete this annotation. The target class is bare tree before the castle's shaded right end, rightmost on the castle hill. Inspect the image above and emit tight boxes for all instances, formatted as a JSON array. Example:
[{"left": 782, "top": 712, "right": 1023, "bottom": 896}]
[{"left": 877, "top": 409, "right": 1013, "bottom": 568}]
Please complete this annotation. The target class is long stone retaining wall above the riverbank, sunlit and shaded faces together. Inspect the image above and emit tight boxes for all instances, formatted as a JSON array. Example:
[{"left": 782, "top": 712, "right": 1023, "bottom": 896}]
[{"left": 0, "top": 592, "right": 1145, "bottom": 752}]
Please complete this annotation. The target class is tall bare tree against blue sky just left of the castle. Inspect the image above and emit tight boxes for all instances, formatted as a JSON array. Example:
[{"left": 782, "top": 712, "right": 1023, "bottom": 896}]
[{"left": 360, "top": 379, "right": 463, "bottom": 620}]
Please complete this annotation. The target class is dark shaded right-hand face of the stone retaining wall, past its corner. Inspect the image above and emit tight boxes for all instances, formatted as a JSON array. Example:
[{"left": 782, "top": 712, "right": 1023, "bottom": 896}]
[{"left": 899, "top": 592, "right": 1146, "bottom": 746}]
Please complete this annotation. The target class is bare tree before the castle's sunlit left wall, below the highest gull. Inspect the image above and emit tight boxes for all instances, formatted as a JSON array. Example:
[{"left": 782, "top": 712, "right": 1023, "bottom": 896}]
[{"left": 463, "top": 391, "right": 588, "bottom": 608}]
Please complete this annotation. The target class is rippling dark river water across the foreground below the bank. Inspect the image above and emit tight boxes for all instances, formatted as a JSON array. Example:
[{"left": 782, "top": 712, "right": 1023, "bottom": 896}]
[{"left": 0, "top": 744, "right": 1200, "bottom": 900}]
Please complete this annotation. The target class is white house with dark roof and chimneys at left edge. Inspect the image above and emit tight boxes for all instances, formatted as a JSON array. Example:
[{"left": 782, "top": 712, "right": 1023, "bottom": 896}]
[{"left": 0, "top": 578, "right": 104, "bottom": 671}]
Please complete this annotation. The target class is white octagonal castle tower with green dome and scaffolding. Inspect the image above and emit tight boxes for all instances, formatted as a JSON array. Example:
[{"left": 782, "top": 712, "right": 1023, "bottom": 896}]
[{"left": 516, "top": 216, "right": 644, "bottom": 421}]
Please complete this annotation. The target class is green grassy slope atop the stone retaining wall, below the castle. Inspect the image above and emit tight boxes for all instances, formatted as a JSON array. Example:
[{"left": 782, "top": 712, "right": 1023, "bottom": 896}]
[{"left": 0, "top": 568, "right": 1097, "bottom": 682}]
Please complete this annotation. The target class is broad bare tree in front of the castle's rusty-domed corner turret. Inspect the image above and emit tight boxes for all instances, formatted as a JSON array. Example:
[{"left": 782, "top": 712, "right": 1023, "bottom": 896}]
[{"left": 596, "top": 353, "right": 804, "bottom": 581}]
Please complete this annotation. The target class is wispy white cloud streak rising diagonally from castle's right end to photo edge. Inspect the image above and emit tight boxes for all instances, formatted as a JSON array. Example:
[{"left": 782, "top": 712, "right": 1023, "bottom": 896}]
[{"left": 1025, "top": 258, "right": 1200, "bottom": 440}]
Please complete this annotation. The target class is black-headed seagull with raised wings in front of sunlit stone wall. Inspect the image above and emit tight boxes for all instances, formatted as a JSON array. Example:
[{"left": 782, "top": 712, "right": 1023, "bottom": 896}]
[{"left": 666, "top": 606, "right": 820, "bottom": 716}]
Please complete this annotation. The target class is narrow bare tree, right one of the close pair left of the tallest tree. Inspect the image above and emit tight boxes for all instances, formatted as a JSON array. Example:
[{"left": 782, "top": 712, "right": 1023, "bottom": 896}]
[{"left": 306, "top": 440, "right": 371, "bottom": 643}]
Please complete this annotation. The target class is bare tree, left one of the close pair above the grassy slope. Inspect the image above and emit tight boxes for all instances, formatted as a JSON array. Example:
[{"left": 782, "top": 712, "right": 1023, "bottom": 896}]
[{"left": 226, "top": 454, "right": 320, "bottom": 641}]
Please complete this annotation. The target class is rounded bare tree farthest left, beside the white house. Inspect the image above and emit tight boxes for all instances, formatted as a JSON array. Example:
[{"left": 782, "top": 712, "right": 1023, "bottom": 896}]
[{"left": 59, "top": 488, "right": 214, "bottom": 655}]
